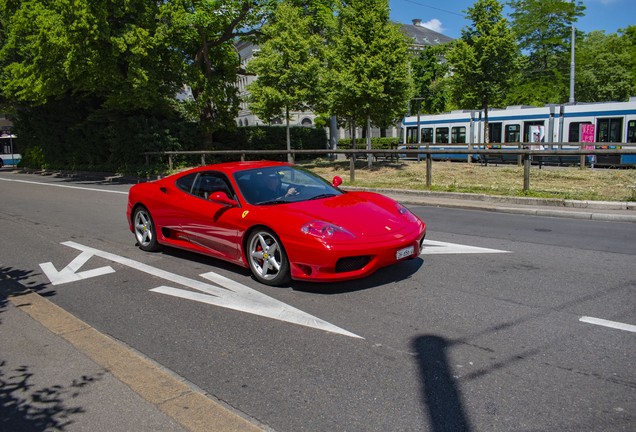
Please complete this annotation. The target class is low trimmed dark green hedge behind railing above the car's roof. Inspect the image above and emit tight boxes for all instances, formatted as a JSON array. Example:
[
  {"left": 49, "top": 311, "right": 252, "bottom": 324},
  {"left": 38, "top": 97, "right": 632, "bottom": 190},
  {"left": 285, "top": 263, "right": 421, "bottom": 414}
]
[{"left": 215, "top": 126, "right": 329, "bottom": 162}]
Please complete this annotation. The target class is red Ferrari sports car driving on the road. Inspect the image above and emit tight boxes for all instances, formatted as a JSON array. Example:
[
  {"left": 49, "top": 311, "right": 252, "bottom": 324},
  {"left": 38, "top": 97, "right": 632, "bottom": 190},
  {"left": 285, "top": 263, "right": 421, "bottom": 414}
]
[{"left": 126, "top": 162, "right": 426, "bottom": 285}]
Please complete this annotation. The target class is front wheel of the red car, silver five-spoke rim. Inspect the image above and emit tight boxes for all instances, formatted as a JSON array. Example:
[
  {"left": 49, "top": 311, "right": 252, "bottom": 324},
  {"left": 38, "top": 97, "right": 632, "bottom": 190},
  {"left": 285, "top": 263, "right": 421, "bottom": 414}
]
[{"left": 246, "top": 228, "right": 291, "bottom": 286}]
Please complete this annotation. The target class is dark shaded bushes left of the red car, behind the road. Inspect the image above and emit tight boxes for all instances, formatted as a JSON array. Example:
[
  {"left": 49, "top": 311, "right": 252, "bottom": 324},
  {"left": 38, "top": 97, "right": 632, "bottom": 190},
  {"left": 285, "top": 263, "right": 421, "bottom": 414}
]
[{"left": 14, "top": 97, "right": 201, "bottom": 174}]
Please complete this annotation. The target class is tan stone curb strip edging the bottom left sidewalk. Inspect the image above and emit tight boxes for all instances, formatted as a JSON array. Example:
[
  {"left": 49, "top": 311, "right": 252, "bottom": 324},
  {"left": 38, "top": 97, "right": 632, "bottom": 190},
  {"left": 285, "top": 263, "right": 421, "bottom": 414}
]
[{"left": 0, "top": 273, "right": 264, "bottom": 432}]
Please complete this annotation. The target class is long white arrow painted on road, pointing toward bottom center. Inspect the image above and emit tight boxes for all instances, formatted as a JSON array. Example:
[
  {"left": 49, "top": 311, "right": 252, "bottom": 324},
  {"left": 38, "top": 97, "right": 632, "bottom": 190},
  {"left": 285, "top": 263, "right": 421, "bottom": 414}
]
[{"left": 49, "top": 242, "right": 364, "bottom": 339}]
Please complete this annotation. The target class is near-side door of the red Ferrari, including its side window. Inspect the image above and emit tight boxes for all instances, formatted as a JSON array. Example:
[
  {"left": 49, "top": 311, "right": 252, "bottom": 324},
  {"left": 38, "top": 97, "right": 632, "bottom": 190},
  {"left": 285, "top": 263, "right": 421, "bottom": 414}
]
[{"left": 179, "top": 172, "right": 242, "bottom": 261}]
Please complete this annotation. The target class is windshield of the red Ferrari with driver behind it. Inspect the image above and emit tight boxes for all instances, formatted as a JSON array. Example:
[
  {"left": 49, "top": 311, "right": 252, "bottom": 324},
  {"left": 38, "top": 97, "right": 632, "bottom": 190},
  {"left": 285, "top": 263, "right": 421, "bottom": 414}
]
[{"left": 234, "top": 165, "right": 343, "bottom": 205}]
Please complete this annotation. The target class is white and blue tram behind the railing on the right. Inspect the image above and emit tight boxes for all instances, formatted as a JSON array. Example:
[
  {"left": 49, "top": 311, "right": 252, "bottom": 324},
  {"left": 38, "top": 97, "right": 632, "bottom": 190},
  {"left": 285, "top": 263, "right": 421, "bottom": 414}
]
[{"left": 398, "top": 97, "right": 636, "bottom": 166}]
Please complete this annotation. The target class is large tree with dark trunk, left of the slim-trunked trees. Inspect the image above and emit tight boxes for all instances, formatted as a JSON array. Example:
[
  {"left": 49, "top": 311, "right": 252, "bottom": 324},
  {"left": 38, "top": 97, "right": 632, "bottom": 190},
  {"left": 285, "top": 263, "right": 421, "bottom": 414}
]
[{"left": 161, "top": 0, "right": 272, "bottom": 139}]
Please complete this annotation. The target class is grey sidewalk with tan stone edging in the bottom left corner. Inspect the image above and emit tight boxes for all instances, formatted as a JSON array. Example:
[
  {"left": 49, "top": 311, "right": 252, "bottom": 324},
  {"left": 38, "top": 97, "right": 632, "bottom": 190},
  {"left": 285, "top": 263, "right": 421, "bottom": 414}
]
[{"left": 0, "top": 274, "right": 262, "bottom": 432}]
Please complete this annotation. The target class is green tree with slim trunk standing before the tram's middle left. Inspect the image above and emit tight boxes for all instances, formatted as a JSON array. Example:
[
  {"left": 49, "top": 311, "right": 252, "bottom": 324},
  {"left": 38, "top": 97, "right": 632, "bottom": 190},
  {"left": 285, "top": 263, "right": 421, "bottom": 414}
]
[{"left": 448, "top": 0, "right": 518, "bottom": 142}]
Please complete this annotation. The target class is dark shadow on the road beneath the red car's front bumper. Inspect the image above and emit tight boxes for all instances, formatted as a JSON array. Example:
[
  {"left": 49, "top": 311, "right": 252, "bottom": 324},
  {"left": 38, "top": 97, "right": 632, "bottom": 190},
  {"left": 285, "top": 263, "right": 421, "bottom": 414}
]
[{"left": 289, "top": 257, "right": 424, "bottom": 294}]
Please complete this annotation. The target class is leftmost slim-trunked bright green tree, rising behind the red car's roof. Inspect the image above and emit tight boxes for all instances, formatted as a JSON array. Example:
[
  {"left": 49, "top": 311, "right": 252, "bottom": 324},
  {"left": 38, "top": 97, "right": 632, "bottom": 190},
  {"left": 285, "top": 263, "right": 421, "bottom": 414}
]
[{"left": 247, "top": 1, "right": 323, "bottom": 160}]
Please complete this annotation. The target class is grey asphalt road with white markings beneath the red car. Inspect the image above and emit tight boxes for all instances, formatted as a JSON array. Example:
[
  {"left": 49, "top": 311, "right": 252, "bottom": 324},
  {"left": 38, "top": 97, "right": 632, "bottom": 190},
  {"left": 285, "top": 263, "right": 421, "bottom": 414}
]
[{"left": 0, "top": 173, "right": 636, "bottom": 431}]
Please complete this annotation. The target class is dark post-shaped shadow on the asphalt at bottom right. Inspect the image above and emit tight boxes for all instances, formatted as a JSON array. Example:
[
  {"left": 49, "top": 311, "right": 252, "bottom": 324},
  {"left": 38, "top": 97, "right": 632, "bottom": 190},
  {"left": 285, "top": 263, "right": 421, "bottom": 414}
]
[{"left": 412, "top": 335, "right": 471, "bottom": 432}]
